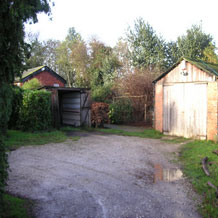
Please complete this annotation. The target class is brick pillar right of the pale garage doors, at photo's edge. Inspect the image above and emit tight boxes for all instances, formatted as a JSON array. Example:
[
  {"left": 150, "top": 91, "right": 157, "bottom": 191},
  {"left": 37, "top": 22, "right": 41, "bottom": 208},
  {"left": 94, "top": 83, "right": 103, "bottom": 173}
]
[{"left": 207, "top": 82, "right": 218, "bottom": 140}]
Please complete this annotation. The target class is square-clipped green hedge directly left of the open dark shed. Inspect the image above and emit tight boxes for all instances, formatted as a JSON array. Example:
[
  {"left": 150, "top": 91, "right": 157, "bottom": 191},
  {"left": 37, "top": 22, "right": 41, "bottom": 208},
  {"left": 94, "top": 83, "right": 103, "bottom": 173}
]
[{"left": 19, "top": 90, "right": 51, "bottom": 131}]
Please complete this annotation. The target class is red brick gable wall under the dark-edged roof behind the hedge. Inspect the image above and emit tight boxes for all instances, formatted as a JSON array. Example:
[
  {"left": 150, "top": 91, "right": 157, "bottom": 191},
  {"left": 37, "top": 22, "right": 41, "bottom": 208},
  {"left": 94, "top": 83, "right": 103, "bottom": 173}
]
[{"left": 25, "top": 71, "right": 65, "bottom": 87}]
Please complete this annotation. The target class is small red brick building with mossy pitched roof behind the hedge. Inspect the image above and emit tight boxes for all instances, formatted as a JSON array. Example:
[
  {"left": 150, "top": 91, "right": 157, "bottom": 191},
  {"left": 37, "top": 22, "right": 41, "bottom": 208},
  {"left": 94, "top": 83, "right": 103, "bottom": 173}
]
[{"left": 15, "top": 66, "right": 66, "bottom": 87}]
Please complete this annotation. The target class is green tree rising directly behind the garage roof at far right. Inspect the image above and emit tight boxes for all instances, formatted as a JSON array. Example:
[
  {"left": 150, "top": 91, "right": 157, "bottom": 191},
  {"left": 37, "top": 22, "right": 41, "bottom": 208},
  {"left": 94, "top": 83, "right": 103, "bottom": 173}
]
[{"left": 177, "top": 25, "right": 218, "bottom": 63}]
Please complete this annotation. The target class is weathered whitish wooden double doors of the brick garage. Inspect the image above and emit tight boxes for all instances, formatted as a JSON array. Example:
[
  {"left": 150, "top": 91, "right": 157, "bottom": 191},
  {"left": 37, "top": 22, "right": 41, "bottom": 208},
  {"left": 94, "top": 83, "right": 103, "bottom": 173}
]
[{"left": 163, "top": 83, "right": 207, "bottom": 139}]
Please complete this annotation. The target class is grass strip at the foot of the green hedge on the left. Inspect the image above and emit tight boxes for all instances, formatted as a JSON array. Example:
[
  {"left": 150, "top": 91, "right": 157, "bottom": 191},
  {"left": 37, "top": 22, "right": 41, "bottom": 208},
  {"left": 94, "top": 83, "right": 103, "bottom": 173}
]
[{"left": 5, "top": 130, "right": 67, "bottom": 150}]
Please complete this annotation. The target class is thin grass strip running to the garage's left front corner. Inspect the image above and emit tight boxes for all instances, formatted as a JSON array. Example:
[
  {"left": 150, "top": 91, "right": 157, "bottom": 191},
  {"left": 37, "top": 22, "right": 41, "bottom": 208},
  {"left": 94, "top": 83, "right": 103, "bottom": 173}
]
[{"left": 96, "top": 129, "right": 163, "bottom": 139}]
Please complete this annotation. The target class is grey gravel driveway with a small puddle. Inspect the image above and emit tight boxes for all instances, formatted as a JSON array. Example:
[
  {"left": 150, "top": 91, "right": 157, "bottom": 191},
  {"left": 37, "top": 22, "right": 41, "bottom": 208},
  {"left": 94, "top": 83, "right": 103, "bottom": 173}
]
[{"left": 7, "top": 133, "right": 200, "bottom": 218}]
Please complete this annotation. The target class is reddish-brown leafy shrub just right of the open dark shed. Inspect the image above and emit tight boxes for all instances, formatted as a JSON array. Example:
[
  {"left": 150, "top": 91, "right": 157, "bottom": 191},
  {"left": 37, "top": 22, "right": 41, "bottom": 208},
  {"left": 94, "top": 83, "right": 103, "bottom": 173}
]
[{"left": 91, "top": 102, "right": 109, "bottom": 127}]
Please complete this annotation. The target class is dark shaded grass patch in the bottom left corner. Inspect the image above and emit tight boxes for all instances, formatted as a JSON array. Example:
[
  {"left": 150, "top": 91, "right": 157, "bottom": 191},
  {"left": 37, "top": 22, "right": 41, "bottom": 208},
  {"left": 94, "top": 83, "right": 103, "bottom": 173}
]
[{"left": 0, "top": 194, "right": 32, "bottom": 218}]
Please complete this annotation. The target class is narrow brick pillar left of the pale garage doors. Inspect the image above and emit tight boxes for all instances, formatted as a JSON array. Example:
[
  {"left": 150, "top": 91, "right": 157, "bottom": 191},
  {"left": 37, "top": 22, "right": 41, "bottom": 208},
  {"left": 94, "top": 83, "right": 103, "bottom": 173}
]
[{"left": 154, "top": 81, "right": 163, "bottom": 132}]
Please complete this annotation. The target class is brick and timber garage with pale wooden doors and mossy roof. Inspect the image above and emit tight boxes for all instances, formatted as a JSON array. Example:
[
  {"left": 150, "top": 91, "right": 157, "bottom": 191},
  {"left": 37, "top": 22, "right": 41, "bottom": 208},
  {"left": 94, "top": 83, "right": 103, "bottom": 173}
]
[{"left": 153, "top": 58, "right": 218, "bottom": 140}]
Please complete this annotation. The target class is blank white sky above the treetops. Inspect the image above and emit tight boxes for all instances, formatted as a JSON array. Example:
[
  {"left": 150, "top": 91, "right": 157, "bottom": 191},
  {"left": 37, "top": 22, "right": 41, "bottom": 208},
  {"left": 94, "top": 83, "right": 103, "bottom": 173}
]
[{"left": 26, "top": 0, "right": 218, "bottom": 46}]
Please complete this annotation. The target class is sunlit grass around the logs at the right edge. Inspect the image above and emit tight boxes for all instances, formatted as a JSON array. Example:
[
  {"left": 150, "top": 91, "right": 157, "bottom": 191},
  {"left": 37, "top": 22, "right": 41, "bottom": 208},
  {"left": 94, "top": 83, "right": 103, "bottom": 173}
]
[{"left": 181, "top": 141, "right": 218, "bottom": 218}]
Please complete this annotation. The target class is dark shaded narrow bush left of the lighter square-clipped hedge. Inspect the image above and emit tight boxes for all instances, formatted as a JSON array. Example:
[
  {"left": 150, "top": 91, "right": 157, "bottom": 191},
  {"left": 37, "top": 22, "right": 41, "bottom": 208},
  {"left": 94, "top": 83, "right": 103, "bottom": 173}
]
[{"left": 8, "top": 86, "right": 23, "bottom": 129}]
